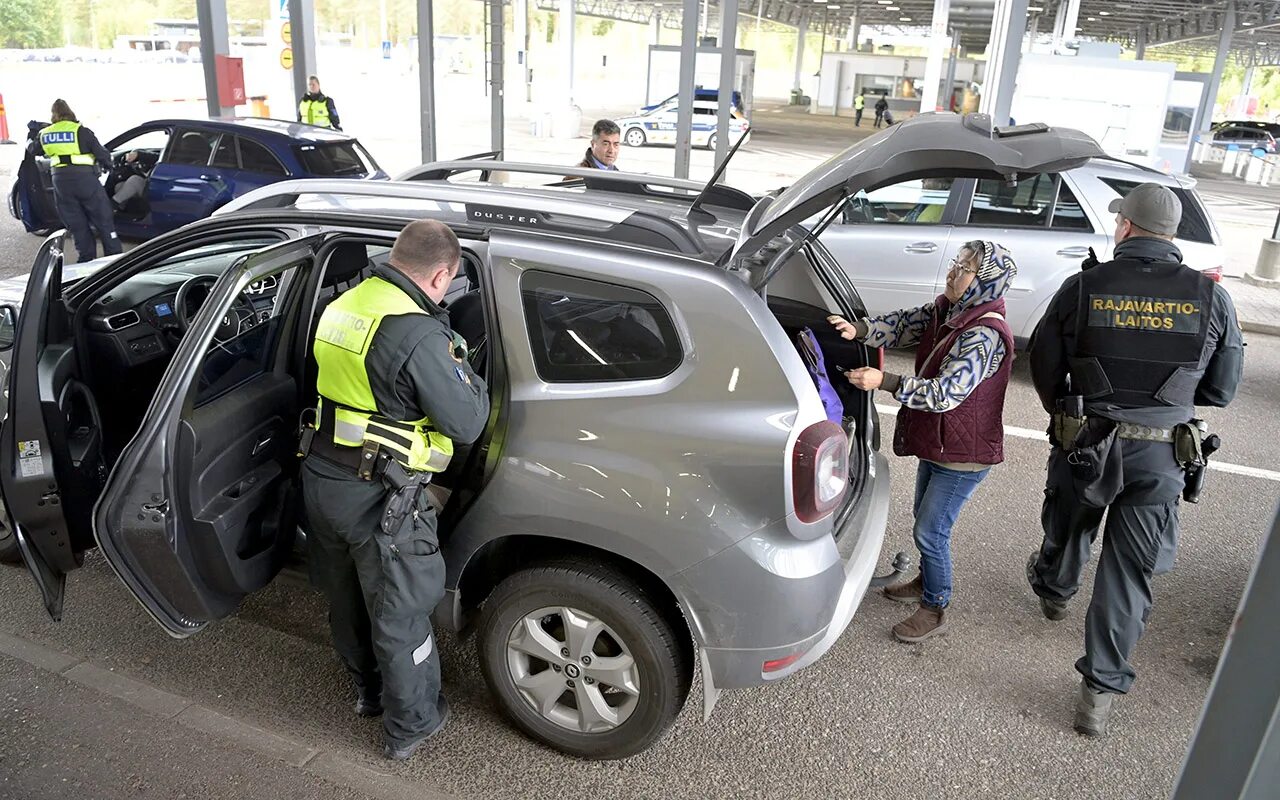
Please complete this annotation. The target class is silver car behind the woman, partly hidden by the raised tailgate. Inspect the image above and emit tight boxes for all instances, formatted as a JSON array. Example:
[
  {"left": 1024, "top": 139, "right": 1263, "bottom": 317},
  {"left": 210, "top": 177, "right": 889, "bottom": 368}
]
[{"left": 822, "top": 159, "right": 1226, "bottom": 343}]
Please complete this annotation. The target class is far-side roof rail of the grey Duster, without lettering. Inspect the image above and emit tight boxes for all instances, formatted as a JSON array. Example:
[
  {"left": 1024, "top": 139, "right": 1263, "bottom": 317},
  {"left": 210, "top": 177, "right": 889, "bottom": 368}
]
[{"left": 394, "top": 154, "right": 755, "bottom": 211}]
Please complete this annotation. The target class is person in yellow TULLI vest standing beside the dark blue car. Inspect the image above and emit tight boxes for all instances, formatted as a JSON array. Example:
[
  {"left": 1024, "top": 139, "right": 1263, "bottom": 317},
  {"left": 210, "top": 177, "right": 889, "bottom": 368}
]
[{"left": 38, "top": 100, "right": 124, "bottom": 261}]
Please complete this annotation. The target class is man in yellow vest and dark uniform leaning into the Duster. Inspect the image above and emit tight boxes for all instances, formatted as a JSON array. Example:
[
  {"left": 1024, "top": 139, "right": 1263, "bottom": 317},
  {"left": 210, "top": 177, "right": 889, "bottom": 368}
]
[{"left": 301, "top": 220, "right": 489, "bottom": 760}]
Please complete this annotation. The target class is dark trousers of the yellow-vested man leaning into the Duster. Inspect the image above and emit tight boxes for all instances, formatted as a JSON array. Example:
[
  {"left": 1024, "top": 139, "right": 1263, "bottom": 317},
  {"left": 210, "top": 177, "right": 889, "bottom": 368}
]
[{"left": 302, "top": 454, "right": 444, "bottom": 745}]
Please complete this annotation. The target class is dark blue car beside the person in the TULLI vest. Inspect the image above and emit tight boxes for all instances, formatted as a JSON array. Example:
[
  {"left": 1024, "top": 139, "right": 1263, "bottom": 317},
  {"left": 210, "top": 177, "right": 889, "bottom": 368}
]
[{"left": 9, "top": 118, "right": 388, "bottom": 239}]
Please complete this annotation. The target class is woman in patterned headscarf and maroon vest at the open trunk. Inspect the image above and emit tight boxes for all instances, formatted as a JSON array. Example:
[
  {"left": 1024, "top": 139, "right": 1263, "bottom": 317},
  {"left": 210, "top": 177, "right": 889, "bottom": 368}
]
[{"left": 829, "top": 241, "right": 1018, "bottom": 643}]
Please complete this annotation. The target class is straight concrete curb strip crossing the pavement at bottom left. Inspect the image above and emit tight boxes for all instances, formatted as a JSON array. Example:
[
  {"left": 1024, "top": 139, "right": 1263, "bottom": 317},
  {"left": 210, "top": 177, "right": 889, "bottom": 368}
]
[{"left": 0, "top": 632, "right": 453, "bottom": 800}]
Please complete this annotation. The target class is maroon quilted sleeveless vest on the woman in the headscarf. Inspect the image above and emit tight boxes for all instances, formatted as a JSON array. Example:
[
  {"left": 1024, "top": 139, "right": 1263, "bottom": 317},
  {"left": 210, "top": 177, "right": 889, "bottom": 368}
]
[{"left": 893, "top": 296, "right": 1014, "bottom": 463}]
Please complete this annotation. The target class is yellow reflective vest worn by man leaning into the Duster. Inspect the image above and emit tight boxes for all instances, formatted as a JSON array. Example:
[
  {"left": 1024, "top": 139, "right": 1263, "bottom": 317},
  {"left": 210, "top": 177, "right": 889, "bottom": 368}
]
[{"left": 314, "top": 278, "right": 453, "bottom": 472}]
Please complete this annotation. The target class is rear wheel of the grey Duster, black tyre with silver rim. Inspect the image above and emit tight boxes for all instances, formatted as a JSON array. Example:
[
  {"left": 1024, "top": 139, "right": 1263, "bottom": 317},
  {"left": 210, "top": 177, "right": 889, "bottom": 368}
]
[{"left": 477, "top": 561, "right": 692, "bottom": 759}]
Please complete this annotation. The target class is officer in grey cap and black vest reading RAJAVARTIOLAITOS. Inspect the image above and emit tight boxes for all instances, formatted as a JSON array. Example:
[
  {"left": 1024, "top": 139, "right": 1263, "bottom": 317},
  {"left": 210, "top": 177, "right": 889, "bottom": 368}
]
[{"left": 1027, "top": 183, "right": 1244, "bottom": 736}]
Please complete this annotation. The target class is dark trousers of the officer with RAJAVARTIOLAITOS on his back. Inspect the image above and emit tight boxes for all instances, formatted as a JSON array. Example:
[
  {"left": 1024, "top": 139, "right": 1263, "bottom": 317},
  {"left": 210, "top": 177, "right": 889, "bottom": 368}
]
[{"left": 1030, "top": 439, "right": 1184, "bottom": 694}]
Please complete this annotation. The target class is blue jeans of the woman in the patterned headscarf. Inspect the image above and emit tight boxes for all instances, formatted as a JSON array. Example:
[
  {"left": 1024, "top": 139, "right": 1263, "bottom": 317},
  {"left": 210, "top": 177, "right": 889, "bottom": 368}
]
[{"left": 913, "top": 460, "right": 991, "bottom": 608}]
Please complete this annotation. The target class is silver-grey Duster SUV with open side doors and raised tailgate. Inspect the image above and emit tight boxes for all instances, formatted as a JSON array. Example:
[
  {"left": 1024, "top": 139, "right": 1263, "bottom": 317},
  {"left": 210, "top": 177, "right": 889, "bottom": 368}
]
[{"left": 0, "top": 116, "right": 1098, "bottom": 758}]
